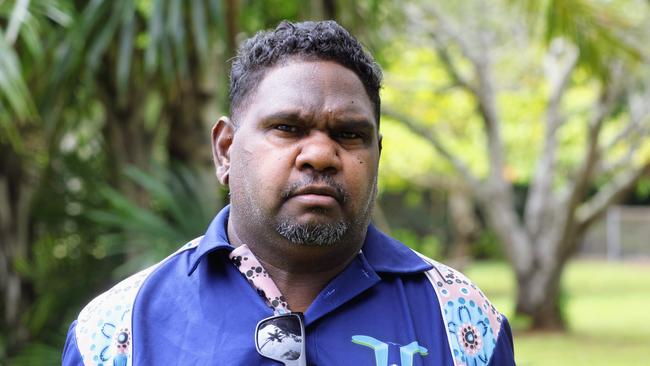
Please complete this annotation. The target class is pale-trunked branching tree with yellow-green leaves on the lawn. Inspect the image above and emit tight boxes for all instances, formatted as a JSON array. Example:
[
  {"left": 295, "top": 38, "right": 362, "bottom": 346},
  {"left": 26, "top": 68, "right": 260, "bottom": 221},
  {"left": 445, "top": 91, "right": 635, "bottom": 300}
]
[{"left": 383, "top": 0, "right": 650, "bottom": 329}]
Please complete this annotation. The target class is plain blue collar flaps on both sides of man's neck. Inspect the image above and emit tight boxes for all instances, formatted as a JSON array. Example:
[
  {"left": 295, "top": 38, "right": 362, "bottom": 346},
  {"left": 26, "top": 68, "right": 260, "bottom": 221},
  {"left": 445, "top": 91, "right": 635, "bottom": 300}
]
[{"left": 188, "top": 205, "right": 433, "bottom": 276}]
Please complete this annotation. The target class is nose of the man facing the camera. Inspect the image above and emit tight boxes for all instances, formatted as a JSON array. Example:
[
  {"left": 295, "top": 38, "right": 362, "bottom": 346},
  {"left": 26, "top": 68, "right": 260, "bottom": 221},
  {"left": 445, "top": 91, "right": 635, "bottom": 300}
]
[{"left": 296, "top": 131, "right": 342, "bottom": 174}]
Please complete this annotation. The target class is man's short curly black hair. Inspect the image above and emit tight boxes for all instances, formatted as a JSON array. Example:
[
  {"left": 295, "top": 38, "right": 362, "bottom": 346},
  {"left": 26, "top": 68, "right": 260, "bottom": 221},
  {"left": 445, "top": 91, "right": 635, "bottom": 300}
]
[{"left": 230, "top": 20, "right": 382, "bottom": 127}]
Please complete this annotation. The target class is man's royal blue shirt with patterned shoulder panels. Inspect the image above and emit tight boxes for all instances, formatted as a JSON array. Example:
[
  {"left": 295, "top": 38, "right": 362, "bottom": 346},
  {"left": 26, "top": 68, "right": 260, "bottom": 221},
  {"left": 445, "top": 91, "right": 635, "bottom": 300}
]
[{"left": 63, "top": 207, "right": 514, "bottom": 366}]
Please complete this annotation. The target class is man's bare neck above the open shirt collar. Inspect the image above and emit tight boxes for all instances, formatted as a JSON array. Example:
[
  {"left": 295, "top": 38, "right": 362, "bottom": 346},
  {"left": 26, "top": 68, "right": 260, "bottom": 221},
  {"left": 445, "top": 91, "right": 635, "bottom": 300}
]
[{"left": 228, "top": 214, "right": 365, "bottom": 312}]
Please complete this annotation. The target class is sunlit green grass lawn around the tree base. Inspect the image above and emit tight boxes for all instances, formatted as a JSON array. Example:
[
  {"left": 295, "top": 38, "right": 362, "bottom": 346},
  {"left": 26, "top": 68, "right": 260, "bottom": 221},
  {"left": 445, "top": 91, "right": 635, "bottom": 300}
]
[{"left": 465, "top": 260, "right": 650, "bottom": 366}]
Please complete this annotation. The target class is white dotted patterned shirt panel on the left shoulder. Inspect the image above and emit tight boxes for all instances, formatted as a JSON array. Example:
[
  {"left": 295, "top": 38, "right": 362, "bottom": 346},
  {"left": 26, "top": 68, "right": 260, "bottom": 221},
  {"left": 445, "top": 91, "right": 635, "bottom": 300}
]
[{"left": 75, "top": 237, "right": 202, "bottom": 366}]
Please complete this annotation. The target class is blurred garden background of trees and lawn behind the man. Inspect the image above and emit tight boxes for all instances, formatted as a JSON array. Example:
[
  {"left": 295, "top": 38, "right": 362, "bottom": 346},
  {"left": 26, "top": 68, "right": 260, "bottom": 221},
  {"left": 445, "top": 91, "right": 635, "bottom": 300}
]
[{"left": 0, "top": 0, "right": 650, "bottom": 365}]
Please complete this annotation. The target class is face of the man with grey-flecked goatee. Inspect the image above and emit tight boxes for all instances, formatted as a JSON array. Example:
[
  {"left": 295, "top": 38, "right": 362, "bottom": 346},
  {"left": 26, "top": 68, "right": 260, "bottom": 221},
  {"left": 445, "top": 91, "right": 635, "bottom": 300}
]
[{"left": 216, "top": 60, "right": 380, "bottom": 245}]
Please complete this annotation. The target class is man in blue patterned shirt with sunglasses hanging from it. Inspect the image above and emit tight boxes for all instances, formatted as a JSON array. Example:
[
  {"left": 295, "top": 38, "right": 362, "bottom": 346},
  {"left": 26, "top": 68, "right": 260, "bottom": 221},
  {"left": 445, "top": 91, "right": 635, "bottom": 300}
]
[{"left": 63, "top": 21, "right": 514, "bottom": 366}]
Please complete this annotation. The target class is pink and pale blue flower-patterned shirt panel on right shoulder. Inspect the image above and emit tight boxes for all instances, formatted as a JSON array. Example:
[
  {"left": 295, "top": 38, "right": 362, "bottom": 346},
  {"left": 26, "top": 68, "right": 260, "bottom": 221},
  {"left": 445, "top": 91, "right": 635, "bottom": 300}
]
[{"left": 420, "top": 255, "right": 502, "bottom": 366}]
